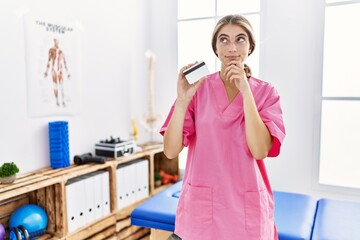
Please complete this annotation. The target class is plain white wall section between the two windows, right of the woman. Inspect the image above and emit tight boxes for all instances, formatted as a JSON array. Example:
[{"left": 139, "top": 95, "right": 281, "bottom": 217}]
[{"left": 260, "top": 0, "right": 324, "bottom": 198}]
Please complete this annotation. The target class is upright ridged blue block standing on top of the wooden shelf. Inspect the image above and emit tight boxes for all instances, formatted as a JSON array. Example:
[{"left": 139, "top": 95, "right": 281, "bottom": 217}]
[{"left": 48, "top": 121, "right": 70, "bottom": 169}]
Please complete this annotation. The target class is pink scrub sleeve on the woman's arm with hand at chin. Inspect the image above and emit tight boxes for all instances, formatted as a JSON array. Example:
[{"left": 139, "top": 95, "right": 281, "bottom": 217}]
[{"left": 259, "top": 86, "right": 285, "bottom": 157}]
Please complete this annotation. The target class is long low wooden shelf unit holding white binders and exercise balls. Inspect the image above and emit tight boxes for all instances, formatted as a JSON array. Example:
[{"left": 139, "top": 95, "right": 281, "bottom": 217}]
[{"left": 0, "top": 146, "right": 179, "bottom": 240}]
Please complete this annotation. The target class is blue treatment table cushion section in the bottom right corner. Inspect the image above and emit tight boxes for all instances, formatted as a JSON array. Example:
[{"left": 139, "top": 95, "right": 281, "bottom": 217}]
[{"left": 312, "top": 199, "right": 360, "bottom": 240}]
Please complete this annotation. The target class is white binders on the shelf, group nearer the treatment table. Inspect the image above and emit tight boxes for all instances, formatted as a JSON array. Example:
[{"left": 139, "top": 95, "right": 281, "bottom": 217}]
[{"left": 116, "top": 159, "right": 149, "bottom": 210}]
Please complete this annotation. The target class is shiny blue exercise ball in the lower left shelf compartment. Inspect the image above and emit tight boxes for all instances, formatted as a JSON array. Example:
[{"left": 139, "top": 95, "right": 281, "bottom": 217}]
[{"left": 9, "top": 204, "right": 48, "bottom": 234}]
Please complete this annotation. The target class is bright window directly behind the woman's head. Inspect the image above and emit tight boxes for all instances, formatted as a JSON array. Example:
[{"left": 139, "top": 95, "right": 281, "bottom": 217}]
[{"left": 178, "top": 0, "right": 260, "bottom": 169}]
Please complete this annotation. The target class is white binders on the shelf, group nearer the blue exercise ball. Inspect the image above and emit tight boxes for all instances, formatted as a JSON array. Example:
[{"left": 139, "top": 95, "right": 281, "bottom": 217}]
[{"left": 65, "top": 171, "right": 110, "bottom": 233}]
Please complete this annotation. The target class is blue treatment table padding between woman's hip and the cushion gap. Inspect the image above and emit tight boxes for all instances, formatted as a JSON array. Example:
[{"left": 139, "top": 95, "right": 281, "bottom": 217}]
[{"left": 273, "top": 191, "right": 317, "bottom": 240}]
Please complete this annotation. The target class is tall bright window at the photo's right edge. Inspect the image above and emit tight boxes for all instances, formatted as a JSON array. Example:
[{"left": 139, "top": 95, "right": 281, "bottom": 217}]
[{"left": 319, "top": 0, "right": 360, "bottom": 188}]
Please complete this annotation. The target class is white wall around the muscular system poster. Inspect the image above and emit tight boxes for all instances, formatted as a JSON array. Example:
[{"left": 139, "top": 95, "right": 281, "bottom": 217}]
[{"left": 0, "top": 0, "right": 149, "bottom": 173}]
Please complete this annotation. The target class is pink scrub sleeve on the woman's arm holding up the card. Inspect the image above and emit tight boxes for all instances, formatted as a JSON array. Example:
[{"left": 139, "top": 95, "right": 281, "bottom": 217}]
[{"left": 160, "top": 100, "right": 195, "bottom": 147}]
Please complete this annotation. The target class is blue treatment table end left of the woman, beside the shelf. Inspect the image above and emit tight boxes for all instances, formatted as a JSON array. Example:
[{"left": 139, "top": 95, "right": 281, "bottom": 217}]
[{"left": 130, "top": 181, "right": 182, "bottom": 232}]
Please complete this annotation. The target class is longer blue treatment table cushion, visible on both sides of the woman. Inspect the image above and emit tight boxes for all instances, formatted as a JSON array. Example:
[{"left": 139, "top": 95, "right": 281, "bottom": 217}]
[{"left": 130, "top": 181, "right": 317, "bottom": 240}]
